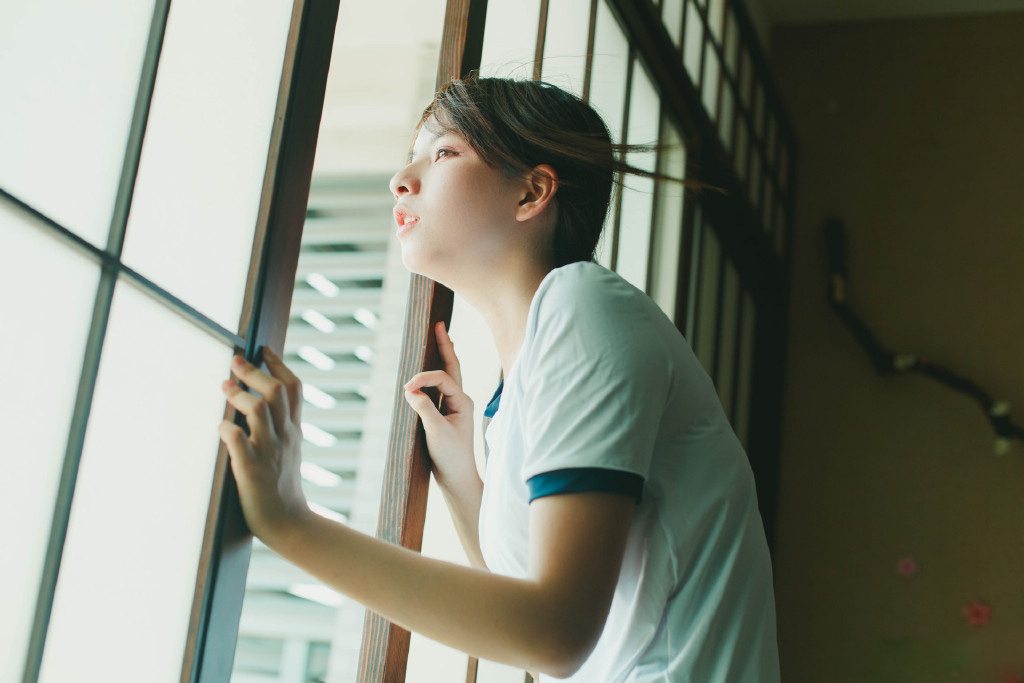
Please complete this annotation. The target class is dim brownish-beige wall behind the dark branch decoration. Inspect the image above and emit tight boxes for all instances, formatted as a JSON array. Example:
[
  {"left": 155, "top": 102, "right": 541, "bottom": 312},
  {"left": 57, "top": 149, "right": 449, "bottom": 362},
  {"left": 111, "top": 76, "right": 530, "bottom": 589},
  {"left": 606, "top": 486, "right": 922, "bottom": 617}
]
[{"left": 772, "top": 13, "right": 1024, "bottom": 683}]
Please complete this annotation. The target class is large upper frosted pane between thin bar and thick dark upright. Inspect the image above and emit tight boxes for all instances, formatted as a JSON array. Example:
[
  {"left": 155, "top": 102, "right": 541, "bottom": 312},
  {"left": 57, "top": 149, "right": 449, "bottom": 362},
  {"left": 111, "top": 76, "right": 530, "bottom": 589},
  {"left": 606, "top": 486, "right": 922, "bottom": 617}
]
[{"left": 124, "top": 0, "right": 292, "bottom": 330}]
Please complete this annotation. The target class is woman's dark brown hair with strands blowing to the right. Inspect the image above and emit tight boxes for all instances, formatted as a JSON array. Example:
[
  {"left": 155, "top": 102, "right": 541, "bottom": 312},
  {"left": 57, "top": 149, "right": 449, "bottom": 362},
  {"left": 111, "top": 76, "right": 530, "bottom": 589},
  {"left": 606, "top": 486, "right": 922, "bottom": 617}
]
[{"left": 420, "top": 77, "right": 690, "bottom": 266}]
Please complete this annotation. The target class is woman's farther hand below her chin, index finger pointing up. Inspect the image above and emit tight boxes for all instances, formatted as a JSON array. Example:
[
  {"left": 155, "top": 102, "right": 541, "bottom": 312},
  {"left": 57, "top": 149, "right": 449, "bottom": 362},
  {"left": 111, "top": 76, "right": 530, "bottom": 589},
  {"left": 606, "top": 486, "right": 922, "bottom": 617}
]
[{"left": 406, "top": 323, "right": 479, "bottom": 487}]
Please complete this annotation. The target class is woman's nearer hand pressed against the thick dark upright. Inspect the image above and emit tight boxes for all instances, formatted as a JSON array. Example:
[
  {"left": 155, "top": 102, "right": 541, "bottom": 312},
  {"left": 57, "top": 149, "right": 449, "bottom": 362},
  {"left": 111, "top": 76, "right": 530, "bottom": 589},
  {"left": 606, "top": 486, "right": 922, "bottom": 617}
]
[{"left": 219, "top": 347, "right": 312, "bottom": 547}]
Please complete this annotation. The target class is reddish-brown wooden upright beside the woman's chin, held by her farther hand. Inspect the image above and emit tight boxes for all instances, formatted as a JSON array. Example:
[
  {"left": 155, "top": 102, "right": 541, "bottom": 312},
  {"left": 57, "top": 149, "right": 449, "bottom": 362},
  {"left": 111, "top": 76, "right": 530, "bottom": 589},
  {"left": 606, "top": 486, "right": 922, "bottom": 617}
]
[{"left": 357, "top": 0, "right": 487, "bottom": 683}]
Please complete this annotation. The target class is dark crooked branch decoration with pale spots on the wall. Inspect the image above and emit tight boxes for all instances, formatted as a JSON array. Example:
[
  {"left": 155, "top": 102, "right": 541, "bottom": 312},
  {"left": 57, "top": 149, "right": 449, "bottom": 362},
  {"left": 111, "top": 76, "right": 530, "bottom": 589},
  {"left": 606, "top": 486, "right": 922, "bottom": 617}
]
[{"left": 823, "top": 219, "right": 1024, "bottom": 455}]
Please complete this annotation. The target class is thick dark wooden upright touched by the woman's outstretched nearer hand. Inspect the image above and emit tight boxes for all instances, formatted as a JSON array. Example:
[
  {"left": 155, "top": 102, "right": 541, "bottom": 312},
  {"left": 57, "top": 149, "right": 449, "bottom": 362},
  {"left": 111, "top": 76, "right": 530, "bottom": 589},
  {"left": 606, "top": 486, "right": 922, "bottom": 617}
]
[{"left": 181, "top": 0, "right": 338, "bottom": 683}]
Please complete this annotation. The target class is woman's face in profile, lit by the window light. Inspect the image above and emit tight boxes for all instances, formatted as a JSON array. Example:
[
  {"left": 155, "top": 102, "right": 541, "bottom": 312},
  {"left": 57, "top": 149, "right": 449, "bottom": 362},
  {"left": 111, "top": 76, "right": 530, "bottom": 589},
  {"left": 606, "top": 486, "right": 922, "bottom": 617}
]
[{"left": 390, "top": 118, "right": 522, "bottom": 287}]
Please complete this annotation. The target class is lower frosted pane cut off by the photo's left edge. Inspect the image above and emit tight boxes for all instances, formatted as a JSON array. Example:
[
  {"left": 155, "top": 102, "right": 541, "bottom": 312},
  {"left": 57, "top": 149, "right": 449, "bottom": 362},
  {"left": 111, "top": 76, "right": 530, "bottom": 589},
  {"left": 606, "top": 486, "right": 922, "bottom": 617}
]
[{"left": 0, "top": 200, "right": 99, "bottom": 681}]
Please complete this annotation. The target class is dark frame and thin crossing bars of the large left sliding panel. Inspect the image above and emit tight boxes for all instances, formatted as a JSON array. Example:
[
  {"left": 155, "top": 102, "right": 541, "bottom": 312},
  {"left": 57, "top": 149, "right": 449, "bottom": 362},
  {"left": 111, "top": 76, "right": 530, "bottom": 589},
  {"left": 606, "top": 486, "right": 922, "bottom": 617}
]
[{"left": 6, "top": 0, "right": 338, "bottom": 683}]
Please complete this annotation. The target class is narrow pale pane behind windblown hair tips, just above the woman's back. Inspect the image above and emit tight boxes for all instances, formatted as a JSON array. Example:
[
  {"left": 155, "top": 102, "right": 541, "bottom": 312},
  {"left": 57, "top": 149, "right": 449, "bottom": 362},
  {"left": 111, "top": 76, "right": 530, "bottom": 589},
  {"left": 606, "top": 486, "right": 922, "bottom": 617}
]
[{"left": 650, "top": 119, "right": 686, "bottom": 324}]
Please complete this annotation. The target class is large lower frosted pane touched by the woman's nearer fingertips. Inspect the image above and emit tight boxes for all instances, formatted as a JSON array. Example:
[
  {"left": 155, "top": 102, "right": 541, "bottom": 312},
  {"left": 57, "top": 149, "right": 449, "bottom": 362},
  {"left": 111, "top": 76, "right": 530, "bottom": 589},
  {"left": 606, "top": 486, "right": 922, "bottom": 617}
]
[{"left": 39, "top": 284, "right": 231, "bottom": 683}]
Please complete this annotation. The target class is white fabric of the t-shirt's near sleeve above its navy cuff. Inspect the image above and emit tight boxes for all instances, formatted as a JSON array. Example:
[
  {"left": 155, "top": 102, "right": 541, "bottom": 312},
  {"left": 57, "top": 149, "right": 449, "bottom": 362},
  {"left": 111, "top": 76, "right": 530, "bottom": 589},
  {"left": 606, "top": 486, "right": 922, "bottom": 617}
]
[{"left": 518, "top": 263, "right": 671, "bottom": 480}]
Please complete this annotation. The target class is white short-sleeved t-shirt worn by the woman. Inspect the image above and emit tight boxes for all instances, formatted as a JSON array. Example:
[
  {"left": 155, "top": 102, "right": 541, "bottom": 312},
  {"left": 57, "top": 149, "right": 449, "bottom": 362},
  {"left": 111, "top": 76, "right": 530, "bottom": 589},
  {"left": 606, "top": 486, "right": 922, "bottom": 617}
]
[{"left": 480, "top": 262, "right": 779, "bottom": 683}]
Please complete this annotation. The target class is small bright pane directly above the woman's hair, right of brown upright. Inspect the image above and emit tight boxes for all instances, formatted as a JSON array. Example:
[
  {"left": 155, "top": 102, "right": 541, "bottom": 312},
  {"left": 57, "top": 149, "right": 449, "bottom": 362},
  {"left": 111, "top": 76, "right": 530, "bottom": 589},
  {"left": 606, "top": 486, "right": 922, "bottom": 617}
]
[{"left": 480, "top": 0, "right": 541, "bottom": 79}]
